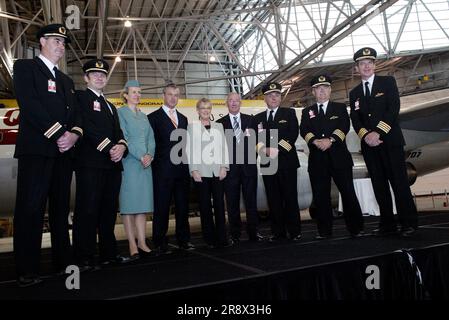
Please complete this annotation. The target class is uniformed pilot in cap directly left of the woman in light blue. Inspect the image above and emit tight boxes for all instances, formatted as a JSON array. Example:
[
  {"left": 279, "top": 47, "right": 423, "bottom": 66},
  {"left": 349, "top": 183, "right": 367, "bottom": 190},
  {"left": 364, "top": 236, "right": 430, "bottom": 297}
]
[{"left": 73, "top": 59, "right": 129, "bottom": 270}]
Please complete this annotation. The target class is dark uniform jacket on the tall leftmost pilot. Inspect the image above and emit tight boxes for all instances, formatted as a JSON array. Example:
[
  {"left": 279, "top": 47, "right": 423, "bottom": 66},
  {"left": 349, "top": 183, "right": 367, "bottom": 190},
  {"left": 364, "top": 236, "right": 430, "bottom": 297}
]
[{"left": 14, "top": 57, "right": 83, "bottom": 158}]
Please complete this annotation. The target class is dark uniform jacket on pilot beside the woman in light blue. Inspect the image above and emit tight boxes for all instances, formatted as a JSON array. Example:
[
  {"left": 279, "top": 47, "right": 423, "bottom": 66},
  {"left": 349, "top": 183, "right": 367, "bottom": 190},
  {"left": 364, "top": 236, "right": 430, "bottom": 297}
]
[{"left": 76, "top": 89, "right": 128, "bottom": 170}]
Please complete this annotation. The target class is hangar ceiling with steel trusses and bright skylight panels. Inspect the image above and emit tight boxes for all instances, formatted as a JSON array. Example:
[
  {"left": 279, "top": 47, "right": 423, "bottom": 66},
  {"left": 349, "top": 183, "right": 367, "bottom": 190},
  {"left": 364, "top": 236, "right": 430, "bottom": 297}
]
[{"left": 0, "top": 0, "right": 449, "bottom": 102}]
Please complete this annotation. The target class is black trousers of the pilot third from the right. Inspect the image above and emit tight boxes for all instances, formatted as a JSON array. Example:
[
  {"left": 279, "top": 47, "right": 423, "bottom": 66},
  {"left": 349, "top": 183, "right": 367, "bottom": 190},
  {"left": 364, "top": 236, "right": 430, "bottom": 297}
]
[{"left": 263, "top": 168, "right": 301, "bottom": 238}]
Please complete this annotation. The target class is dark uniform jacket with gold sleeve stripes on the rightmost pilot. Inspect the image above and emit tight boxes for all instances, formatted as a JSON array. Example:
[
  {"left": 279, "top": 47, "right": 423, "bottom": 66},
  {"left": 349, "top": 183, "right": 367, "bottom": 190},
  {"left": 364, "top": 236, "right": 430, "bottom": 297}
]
[{"left": 349, "top": 75, "right": 405, "bottom": 150}]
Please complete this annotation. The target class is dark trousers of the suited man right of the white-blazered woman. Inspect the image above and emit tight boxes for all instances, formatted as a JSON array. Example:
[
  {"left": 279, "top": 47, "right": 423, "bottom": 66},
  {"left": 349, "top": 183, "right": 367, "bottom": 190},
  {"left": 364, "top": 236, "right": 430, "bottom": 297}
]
[{"left": 224, "top": 165, "right": 259, "bottom": 239}]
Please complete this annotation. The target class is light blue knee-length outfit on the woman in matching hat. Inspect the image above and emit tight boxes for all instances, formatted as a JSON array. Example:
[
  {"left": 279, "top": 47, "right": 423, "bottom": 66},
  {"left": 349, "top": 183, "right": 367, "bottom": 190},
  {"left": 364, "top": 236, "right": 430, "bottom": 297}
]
[{"left": 118, "top": 106, "right": 156, "bottom": 214}]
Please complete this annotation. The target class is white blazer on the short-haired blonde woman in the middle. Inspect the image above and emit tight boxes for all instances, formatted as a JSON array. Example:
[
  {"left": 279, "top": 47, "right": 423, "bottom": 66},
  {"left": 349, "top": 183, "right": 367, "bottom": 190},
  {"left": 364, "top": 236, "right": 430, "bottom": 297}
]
[{"left": 186, "top": 121, "right": 229, "bottom": 177}]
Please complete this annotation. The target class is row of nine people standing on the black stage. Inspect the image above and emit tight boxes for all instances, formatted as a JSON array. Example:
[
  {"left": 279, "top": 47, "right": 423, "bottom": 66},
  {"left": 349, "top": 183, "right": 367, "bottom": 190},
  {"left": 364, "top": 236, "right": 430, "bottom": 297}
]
[{"left": 14, "top": 24, "right": 417, "bottom": 286}]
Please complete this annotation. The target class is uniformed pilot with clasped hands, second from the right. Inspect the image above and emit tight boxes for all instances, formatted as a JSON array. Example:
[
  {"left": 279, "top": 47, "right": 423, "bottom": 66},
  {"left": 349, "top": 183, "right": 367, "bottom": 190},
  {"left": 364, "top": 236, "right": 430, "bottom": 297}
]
[{"left": 299, "top": 75, "right": 363, "bottom": 239}]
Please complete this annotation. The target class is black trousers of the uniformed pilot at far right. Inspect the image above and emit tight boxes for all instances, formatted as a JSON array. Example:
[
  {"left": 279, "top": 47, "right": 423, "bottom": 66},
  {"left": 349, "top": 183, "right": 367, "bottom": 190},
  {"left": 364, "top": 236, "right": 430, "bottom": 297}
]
[{"left": 362, "top": 144, "right": 418, "bottom": 228}]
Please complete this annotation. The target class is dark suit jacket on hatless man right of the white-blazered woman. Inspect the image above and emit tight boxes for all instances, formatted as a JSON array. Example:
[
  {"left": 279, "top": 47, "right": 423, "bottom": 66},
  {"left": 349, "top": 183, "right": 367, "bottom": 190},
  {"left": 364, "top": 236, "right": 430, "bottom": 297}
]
[{"left": 217, "top": 113, "right": 257, "bottom": 176}]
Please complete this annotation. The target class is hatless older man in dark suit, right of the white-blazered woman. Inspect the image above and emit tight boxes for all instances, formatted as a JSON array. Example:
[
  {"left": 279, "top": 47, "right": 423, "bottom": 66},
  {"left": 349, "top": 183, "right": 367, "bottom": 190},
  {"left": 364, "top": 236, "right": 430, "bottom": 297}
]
[{"left": 217, "top": 92, "right": 263, "bottom": 244}]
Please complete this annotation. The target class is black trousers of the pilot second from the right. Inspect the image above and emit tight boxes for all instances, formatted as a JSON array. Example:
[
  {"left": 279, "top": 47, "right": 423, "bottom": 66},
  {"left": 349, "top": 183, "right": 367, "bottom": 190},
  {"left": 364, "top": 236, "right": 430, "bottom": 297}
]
[{"left": 309, "top": 165, "right": 363, "bottom": 236}]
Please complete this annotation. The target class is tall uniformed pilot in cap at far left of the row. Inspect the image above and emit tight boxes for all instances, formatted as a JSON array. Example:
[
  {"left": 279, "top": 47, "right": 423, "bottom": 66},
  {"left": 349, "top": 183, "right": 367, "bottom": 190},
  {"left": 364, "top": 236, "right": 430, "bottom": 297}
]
[{"left": 14, "top": 24, "right": 83, "bottom": 286}]
